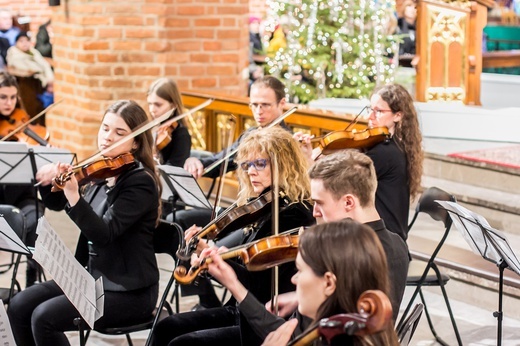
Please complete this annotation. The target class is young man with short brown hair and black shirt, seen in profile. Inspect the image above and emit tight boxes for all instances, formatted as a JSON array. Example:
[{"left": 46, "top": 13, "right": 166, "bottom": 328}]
[{"left": 266, "top": 150, "right": 410, "bottom": 321}]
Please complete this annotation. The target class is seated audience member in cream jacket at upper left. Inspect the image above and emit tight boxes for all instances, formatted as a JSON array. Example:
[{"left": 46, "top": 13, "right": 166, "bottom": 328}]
[{"left": 7, "top": 32, "right": 54, "bottom": 92}]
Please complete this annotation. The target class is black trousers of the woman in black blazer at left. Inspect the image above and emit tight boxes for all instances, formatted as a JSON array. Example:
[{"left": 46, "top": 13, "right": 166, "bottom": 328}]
[{"left": 7, "top": 281, "right": 158, "bottom": 346}]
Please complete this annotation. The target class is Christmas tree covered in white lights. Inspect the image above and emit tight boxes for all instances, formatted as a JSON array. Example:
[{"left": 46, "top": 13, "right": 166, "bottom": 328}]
[{"left": 266, "top": 0, "right": 398, "bottom": 103}]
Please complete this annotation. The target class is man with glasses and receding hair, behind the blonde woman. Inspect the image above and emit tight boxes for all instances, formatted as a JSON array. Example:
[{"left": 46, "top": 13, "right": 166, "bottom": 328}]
[{"left": 175, "top": 76, "right": 289, "bottom": 229}]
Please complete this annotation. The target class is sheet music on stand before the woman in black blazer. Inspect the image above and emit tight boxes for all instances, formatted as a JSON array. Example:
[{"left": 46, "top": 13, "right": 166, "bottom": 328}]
[{"left": 33, "top": 216, "right": 104, "bottom": 328}]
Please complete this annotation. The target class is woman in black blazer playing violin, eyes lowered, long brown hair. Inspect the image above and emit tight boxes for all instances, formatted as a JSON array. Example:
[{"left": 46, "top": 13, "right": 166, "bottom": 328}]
[{"left": 8, "top": 100, "right": 160, "bottom": 345}]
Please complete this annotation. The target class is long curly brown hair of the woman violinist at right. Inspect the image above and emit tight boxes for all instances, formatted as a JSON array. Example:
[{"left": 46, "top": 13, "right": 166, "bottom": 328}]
[{"left": 373, "top": 84, "right": 424, "bottom": 199}]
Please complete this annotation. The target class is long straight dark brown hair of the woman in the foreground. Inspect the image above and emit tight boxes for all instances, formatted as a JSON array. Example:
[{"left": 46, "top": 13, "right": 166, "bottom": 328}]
[{"left": 299, "top": 219, "right": 397, "bottom": 345}]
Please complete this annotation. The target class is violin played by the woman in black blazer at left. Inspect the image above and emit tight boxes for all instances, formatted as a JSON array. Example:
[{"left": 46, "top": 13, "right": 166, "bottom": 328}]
[{"left": 51, "top": 153, "right": 137, "bottom": 192}]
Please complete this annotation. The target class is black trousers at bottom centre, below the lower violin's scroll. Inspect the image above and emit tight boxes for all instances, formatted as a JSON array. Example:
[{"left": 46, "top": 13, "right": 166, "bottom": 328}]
[{"left": 154, "top": 306, "right": 262, "bottom": 346}]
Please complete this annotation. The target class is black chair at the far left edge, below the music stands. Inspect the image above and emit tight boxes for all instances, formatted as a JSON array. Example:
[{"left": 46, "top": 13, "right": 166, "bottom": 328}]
[{"left": 0, "top": 204, "right": 27, "bottom": 304}]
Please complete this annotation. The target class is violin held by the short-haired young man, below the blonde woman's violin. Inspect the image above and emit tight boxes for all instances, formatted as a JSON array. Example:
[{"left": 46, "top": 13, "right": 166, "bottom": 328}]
[{"left": 173, "top": 228, "right": 301, "bottom": 285}]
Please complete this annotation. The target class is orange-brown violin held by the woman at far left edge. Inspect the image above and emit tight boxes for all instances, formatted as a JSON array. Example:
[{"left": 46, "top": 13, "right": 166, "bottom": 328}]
[{"left": 0, "top": 108, "right": 50, "bottom": 146}]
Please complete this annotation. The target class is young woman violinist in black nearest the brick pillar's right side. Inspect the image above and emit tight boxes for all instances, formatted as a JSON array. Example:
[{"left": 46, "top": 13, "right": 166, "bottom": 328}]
[{"left": 146, "top": 78, "right": 191, "bottom": 167}]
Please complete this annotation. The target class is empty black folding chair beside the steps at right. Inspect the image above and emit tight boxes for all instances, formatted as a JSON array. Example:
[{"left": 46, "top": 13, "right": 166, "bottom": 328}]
[{"left": 397, "top": 187, "right": 462, "bottom": 346}]
